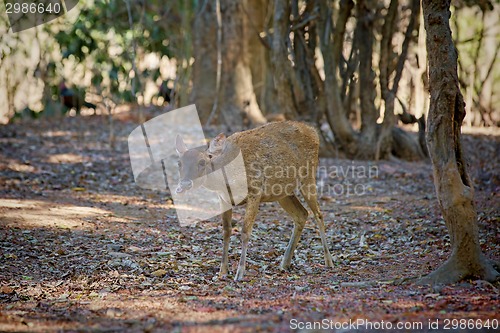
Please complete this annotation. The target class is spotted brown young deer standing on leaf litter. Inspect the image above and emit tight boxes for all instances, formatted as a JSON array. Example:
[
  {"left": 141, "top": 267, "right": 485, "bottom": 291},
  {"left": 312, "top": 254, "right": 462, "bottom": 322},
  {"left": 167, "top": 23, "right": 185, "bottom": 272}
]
[{"left": 175, "top": 121, "right": 333, "bottom": 281}]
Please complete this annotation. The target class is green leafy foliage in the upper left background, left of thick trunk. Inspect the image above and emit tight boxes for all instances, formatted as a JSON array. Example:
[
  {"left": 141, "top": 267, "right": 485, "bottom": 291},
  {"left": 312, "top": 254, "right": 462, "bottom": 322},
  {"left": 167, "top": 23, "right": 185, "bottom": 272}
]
[{"left": 49, "top": 0, "right": 194, "bottom": 101}]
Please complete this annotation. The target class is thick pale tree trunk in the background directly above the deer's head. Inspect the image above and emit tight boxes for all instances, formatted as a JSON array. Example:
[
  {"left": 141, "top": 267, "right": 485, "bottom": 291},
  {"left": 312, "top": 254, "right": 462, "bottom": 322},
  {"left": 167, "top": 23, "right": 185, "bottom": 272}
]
[{"left": 190, "top": 0, "right": 266, "bottom": 128}]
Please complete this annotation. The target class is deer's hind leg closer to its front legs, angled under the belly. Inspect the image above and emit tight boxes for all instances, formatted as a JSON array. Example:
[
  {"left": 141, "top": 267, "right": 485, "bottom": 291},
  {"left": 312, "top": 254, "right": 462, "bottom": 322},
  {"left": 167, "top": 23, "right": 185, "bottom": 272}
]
[{"left": 278, "top": 195, "right": 308, "bottom": 269}]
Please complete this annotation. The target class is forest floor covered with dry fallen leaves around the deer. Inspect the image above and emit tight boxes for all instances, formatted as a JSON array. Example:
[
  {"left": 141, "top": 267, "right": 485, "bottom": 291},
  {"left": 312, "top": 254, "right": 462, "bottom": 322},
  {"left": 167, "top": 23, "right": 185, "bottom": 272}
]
[{"left": 0, "top": 116, "right": 500, "bottom": 332}]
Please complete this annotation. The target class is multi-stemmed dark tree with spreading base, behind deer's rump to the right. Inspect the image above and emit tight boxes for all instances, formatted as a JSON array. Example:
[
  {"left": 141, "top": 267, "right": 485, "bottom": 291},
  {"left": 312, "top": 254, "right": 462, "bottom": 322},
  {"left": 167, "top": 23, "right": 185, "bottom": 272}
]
[{"left": 316, "top": 0, "right": 424, "bottom": 160}]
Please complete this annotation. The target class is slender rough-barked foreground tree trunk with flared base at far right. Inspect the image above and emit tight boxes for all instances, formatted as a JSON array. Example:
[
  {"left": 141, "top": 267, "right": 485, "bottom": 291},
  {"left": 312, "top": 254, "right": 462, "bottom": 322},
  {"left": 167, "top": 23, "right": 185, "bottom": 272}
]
[{"left": 421, "top": 0, "right": 500, "bottom": 284}]
